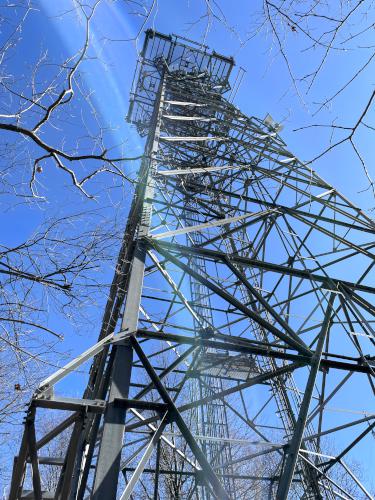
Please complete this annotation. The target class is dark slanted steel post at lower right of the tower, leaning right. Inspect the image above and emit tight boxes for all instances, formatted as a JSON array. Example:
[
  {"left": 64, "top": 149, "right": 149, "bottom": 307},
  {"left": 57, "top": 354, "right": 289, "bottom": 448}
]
[{"left": 276, "top": 293, "right": 335, "bottom": 500}]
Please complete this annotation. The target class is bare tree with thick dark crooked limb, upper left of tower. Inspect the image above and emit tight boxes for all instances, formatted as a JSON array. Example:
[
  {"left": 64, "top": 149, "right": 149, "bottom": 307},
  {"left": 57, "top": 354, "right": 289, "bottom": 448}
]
[{"left": 0, "top": 0, "right": 144, "bottom": 198}]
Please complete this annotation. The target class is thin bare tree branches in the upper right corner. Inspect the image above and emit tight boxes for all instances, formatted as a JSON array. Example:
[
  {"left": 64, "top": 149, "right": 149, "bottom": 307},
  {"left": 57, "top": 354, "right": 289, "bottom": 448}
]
[{"left": 190, "top": 0, "right": 375, "bottom": 199}]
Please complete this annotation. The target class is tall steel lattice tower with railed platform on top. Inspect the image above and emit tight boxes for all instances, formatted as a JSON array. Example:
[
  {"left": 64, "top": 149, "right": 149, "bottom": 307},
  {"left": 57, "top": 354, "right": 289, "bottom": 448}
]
[{"left": 10, "top": 30, "right": 375, "bottom": 500}]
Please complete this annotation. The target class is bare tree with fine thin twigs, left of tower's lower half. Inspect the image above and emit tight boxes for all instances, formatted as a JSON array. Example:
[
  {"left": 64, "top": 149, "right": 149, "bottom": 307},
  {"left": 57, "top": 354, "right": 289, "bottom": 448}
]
[{"left": 0, "top": 213, "right": 117, "bottom": 454}]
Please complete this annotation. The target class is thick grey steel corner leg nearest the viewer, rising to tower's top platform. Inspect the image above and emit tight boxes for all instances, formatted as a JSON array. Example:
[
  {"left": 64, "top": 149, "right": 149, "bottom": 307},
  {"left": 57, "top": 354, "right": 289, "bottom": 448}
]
[{"left": 92, "top": 78, "right": 164, "bottom": 500}]
